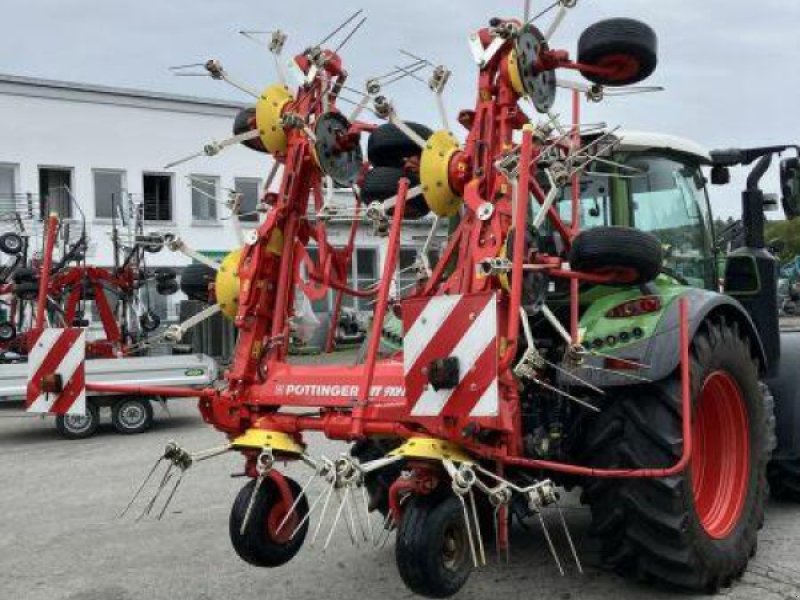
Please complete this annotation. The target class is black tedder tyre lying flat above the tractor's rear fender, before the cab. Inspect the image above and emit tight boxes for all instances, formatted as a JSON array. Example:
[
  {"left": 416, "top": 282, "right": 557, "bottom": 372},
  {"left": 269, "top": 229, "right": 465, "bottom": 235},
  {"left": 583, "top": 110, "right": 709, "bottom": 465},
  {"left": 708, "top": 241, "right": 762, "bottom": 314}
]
[{"left": 569, "top": 227, "right": 664, "bottom": 283}]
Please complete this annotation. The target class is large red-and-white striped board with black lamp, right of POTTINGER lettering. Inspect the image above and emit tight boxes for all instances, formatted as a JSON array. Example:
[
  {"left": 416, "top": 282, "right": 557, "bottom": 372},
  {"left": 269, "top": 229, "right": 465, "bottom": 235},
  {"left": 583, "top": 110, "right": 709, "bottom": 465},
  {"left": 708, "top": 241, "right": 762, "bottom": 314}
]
[{"left": 403, "top": 293, "right": 499, "bottom": 417}]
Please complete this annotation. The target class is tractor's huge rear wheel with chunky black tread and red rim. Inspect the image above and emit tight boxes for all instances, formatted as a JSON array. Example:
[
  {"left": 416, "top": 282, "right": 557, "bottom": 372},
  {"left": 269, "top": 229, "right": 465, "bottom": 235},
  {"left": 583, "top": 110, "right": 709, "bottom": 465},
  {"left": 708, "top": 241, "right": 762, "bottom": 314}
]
[{"left": 583, "top": 319, "right": 775, "bottom": 593}]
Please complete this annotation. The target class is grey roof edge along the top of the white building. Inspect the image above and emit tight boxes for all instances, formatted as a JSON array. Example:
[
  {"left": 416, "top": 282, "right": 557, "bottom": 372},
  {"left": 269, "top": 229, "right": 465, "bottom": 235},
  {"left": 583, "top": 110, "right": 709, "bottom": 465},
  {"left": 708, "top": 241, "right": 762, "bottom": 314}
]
[{"left": 0, "top": 73, "right": 246, "bottom": 116}]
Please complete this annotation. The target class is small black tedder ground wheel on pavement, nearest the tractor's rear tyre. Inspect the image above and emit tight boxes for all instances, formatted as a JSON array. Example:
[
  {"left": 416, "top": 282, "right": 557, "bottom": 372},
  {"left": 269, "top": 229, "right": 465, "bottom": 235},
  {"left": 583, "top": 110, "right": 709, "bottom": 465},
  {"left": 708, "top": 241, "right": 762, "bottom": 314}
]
[{"left": 395, "top": 495, "right": 473, "bottom": 598}]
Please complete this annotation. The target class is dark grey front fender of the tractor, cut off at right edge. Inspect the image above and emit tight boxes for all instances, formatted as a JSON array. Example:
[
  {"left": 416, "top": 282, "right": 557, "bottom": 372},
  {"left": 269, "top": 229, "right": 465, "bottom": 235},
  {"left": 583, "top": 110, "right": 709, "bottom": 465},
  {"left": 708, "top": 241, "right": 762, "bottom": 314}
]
[{"left": 766, "top": 330, "right": 800, "bottom": 460}]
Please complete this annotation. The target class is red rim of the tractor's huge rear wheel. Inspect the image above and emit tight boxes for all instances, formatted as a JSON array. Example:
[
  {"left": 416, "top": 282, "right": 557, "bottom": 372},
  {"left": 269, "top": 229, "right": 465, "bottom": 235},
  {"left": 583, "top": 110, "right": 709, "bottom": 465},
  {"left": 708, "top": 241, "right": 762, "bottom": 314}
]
[{"left": 692, "top": 371, "right": 750, "bottom": 539}]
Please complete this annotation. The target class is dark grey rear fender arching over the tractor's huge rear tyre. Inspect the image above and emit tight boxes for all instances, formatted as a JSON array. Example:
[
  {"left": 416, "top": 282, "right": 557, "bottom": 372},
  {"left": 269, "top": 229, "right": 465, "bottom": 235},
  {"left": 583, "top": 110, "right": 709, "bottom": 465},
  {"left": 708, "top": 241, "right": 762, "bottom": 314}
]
[{"left": 559, "top": 289, "right": 767, "bottom": 387}]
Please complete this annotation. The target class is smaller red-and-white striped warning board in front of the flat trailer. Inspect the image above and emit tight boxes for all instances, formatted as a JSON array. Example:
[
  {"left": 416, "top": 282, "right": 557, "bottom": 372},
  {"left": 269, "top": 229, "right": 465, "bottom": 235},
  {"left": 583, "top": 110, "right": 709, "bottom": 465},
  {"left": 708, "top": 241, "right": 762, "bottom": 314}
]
[{"left": 25, "top": 327, "right": 86, "bottom": 415}]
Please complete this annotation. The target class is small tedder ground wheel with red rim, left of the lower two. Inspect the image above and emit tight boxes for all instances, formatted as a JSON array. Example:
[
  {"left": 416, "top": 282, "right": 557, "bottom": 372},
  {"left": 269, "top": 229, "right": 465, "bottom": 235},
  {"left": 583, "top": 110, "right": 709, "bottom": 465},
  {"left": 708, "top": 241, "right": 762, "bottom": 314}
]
[{"left": 228, "top": 477, "right": 308, "bottom": 567}]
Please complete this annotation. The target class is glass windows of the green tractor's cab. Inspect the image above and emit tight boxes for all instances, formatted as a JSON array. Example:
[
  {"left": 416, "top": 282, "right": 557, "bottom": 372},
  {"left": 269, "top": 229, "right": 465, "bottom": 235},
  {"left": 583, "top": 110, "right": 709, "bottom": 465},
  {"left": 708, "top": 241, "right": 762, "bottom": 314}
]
[{"left": 559, "top": 154, "right": 715, "bottom": 289}]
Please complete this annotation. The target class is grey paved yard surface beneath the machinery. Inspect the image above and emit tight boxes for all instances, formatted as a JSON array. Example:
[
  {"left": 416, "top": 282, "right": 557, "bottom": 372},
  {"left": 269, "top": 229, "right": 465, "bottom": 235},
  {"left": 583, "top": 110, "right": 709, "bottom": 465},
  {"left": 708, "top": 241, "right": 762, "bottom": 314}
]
[{"left": 0, "top": 401, "right": 800, "bottom": 600}]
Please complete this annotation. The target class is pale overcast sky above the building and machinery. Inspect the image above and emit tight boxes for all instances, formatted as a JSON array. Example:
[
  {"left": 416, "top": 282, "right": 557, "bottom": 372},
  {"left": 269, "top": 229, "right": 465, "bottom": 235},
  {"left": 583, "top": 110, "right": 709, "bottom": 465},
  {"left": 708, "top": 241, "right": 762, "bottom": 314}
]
[{"left": 0, "top": 0, "right": 800, "bottom": 216}]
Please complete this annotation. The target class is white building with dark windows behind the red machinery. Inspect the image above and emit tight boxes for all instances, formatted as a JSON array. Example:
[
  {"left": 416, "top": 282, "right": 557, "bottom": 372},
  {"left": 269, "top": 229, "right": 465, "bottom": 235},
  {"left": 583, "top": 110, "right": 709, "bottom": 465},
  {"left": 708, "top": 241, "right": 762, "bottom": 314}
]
[{"left": 0, "top": 75, "right": 440, "bottom": 332}]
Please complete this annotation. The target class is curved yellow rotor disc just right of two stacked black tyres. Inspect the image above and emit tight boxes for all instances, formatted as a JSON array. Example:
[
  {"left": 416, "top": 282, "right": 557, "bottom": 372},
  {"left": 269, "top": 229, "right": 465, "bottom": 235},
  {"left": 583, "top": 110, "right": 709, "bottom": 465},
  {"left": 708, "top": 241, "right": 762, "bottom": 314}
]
[{"left": 419, "top": 130, "right": 463, "bottom": 217}]
